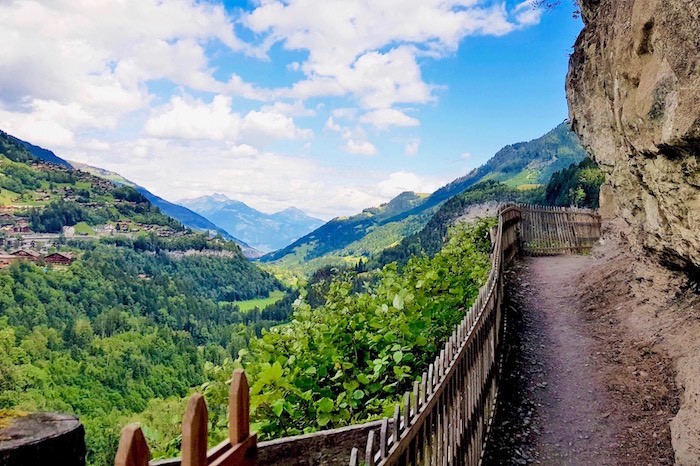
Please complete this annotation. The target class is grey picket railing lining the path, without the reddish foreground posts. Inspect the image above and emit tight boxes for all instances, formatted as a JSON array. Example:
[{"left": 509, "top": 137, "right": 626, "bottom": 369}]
[{"left": 350, "top": 205, "right": 600, "bottom": 466}]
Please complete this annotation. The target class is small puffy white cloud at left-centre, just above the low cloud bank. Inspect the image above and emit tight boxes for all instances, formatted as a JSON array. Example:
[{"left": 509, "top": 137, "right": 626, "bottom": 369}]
[{"left": 144, "top": 95, "right": 242, "bottom": 141}]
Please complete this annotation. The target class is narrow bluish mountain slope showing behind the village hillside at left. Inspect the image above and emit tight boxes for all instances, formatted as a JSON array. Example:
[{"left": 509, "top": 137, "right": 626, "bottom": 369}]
[{"left": 69, "top": 161, "right": 262, "bottom": 259}]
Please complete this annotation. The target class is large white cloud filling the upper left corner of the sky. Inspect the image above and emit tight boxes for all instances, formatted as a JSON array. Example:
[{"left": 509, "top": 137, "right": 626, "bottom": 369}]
[{"left": 0, "top": 0, "right": 263, "bottom": 144}]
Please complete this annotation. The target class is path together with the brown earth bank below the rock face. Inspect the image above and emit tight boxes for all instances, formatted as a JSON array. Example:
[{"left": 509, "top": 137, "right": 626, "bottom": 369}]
[{"left": 485, "top": 219, "right": 700, "bottom": 465}]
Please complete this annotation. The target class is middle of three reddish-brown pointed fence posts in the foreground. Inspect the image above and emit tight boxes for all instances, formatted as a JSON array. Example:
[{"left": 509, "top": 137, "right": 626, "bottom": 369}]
[{"left": 182, "top": 393, "right": 209, "bottom": 466}]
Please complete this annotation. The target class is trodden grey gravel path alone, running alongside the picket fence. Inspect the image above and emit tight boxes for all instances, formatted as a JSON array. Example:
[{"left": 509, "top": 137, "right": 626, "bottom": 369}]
[{"left": 485, "top": 256, "right": 673, "bottom": 465}]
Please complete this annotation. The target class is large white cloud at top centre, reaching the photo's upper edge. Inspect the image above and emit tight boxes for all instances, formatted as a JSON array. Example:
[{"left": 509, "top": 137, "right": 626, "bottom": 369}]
[{"left": 243, "top": 0, "right": 538, "bottom": 108}]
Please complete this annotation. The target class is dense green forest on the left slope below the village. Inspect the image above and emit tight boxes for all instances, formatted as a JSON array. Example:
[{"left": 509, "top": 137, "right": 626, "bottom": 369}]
[{"left": 0, "top": 241, "right": 288, "bottom": 464}]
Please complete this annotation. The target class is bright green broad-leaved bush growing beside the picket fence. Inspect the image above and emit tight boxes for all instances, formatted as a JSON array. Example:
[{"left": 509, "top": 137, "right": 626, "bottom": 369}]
[{"left": 196, "top": 220, "right": 494, "bottom": 441}]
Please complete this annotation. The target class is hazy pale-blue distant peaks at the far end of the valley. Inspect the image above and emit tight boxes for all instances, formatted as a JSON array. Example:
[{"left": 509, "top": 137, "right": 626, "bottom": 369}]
[{"left": 178, "top": 193, "right": 323, "bottom": 251}]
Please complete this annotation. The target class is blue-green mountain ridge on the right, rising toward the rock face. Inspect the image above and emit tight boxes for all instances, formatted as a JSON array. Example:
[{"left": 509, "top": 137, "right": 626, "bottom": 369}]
[{"left": 261, "top": 122, "right": 586, "bottom": 272}]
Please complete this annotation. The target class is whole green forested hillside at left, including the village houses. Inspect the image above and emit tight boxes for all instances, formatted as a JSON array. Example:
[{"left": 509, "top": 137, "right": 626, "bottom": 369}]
[{"left": 0, "top": 134, "right": 295, "bottom": 465}]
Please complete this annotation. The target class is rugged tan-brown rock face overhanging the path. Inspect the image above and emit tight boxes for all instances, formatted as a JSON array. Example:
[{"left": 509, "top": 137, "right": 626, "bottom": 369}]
[{"left": 567, "top": 0, "right": 700, "bottom": 272}]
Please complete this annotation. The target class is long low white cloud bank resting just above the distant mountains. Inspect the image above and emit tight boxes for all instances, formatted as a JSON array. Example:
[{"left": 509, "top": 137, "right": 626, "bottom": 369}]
[{"left": 61, "top": 138, "right": 444, "bottom": 219}]
